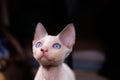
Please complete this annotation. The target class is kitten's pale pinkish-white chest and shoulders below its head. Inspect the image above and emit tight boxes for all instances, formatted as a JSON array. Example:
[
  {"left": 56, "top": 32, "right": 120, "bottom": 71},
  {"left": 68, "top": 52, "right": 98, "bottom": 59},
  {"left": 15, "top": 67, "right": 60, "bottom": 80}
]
[{"left": 34, "top": 63, "right": 75, "bottom": 80}]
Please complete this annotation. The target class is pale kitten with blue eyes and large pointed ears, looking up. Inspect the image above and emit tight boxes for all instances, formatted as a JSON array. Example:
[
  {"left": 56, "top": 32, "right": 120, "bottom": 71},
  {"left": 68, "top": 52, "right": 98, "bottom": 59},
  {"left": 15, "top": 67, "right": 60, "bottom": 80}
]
[{"left": 32, "top": 22, "right": 75, "bottom": 80}]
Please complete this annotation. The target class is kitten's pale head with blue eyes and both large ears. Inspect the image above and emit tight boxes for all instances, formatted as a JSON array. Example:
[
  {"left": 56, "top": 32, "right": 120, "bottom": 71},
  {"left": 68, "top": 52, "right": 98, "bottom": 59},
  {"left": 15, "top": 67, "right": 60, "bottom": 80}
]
[{"left": 33, "top": 23, "right": 75, "bottom": 66}]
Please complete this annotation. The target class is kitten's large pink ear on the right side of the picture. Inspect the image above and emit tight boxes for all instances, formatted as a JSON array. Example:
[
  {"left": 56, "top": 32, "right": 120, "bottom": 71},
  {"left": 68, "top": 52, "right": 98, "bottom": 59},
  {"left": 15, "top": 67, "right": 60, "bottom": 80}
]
[{"left": 59, "top": 23, "right": 75, "bottom": 48}]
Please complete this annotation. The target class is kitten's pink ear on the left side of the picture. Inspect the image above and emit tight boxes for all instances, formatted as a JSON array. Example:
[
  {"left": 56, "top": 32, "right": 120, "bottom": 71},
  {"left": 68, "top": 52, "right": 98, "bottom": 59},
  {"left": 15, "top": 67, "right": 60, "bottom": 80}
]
[{"left": 33, "top": 23, "right": 48, "bottom": 43}]
